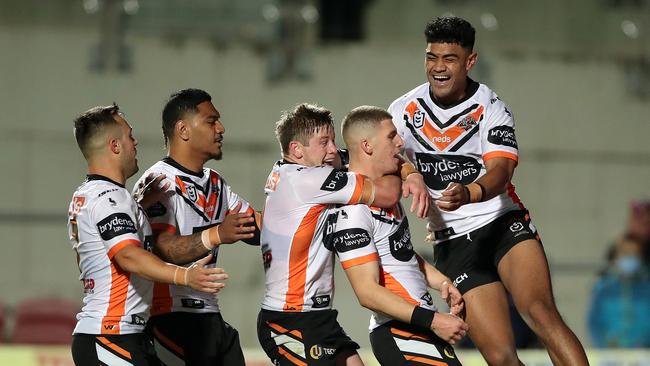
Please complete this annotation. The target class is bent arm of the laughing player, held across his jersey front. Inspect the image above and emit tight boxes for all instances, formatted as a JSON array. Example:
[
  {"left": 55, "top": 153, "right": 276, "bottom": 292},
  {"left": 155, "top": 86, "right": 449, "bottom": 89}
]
[{"left": 436, "top": 157, "right": 517, "bottom": 211}]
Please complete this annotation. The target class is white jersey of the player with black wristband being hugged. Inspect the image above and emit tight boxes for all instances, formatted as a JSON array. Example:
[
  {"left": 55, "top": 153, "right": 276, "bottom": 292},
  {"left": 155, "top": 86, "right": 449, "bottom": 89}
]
[{"left": 325, "top": 204, "right": 436, "bottom": 331}]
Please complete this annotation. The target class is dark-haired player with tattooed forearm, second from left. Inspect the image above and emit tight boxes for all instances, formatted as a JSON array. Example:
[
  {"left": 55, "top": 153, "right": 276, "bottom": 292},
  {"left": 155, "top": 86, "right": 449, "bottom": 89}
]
[{"left": 136, "top": 89, "right": 259, "bottom": 366}]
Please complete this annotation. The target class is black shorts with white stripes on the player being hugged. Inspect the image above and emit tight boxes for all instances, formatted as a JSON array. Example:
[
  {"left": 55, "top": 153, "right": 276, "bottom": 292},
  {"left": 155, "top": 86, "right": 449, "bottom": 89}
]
[{"left": 370, "top": 320, "right": 462, "bottom": 366}]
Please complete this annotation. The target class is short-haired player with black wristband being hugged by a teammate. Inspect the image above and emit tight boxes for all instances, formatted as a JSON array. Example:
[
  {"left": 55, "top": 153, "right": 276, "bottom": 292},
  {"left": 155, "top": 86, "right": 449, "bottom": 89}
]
[{"left": 325, "top": 106, "right": 467, "bottom": 366}]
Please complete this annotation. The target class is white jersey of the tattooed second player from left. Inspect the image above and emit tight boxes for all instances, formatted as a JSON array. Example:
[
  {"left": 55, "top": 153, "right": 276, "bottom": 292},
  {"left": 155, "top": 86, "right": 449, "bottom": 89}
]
[{"left": 135, "top": 157, "right": 253, "bottom": 315}]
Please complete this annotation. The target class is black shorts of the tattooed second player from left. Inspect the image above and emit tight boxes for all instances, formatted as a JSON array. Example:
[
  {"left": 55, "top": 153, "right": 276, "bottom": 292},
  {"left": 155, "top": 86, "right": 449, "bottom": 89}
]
[{"left": 147, "top": 312, "right": 245, "bottom": 366}]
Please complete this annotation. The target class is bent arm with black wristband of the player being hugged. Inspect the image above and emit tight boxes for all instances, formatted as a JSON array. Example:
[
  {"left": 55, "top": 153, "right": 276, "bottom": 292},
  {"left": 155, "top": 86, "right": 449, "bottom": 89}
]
[{"left": 345, "top": 261, "right": 468, "bottom": 345}]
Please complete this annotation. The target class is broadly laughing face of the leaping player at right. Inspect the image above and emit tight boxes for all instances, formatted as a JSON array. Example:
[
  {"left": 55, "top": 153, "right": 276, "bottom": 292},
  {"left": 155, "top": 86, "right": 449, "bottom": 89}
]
[{"left": 424, "top": 43, "right": 477, "bottom": 105}]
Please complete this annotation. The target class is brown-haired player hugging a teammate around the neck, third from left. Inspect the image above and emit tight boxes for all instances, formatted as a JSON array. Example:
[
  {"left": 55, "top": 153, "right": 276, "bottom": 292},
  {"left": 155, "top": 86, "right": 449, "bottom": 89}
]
[{"left": 258, "top": 104, "right": 429, "bottom": 365}]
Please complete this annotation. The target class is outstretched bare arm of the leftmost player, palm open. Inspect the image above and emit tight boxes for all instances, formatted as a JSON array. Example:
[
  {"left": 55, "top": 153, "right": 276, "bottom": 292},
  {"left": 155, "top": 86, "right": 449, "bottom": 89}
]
[{"left": 112, "top": 245, "right": 228, "bottom": 293}]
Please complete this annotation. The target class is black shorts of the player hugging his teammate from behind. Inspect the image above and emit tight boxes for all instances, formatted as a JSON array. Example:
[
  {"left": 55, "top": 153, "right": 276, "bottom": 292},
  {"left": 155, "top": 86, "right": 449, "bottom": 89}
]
[{"left": 257, "top": 309, "right": 359, "bottom": 366}]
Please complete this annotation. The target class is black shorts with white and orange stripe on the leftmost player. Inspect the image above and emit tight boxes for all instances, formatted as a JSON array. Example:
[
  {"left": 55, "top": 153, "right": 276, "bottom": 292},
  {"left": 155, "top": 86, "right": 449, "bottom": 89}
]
[{"left": 72, "top": 333, "right": 158, "bottom": 366}]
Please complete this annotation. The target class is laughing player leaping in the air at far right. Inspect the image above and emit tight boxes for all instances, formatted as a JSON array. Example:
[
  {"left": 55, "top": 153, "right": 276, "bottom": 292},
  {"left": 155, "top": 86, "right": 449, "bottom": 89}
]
[{"left": 388, "top": 17, "right": 587, "bottom": 366}]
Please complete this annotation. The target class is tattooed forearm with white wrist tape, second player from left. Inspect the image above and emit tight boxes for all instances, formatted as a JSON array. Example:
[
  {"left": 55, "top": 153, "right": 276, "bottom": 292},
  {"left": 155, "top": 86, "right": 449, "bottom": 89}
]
[{"left": 154, "top": 202, "right": 254, "bottom": 264}]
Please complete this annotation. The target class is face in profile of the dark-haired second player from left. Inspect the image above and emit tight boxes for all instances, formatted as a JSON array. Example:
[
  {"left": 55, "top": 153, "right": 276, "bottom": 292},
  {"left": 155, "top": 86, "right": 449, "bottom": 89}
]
[{"left": 188, "top": 102, "right": 226, "bottom": 160}]
